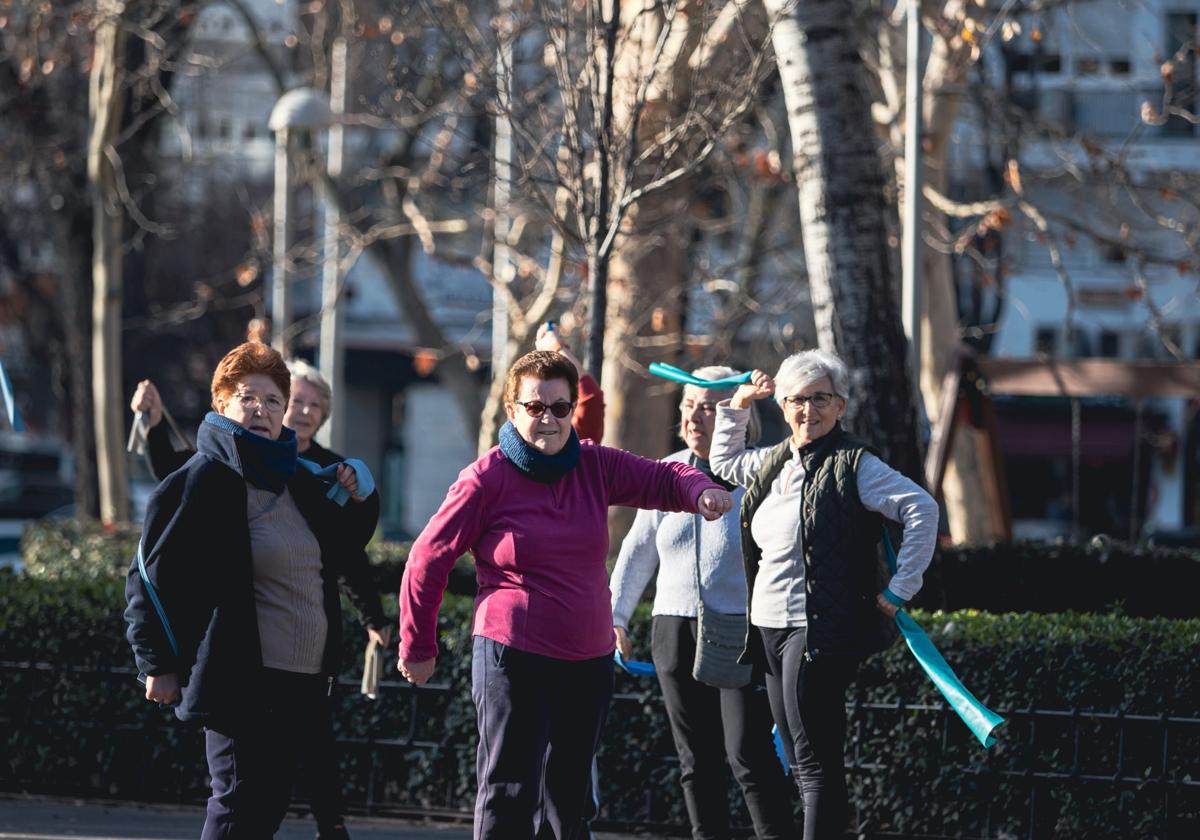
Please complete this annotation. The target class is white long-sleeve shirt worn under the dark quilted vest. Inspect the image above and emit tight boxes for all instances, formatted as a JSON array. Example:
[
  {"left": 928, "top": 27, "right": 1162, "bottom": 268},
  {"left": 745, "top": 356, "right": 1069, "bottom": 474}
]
[{"left": 709, "top": 401, "right": 938, "bottom": 628}]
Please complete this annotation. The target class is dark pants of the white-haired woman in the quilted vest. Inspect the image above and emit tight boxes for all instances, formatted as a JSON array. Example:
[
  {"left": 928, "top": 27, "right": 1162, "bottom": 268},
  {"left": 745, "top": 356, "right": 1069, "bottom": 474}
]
[{"left": 758, "top": 628, "right": 859, "bottom": 840}]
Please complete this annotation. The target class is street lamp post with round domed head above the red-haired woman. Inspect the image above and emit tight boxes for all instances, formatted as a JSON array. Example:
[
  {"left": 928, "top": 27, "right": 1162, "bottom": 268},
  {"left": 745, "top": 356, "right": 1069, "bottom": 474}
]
[{"left": 268, "top": 88, "right": 330, "bottom": 356}]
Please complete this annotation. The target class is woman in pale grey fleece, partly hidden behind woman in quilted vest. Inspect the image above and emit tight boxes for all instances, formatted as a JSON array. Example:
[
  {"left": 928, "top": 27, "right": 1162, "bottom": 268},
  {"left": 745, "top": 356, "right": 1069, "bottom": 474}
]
[{"left": 610, "top": 367, "right": 794, "bottom": 840}]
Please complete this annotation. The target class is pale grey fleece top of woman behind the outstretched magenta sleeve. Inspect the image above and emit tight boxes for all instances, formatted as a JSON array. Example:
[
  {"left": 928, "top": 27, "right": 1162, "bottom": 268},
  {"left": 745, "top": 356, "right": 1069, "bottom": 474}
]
[{"left": 608, "top": 450, "right": 746, "bottom": 629}]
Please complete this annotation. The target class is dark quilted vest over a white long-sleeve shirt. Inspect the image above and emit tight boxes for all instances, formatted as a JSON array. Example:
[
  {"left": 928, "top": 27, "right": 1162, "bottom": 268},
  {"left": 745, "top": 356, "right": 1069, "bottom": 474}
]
[{"left": 740, "top": 426, "right": 895, "bottom": 661}]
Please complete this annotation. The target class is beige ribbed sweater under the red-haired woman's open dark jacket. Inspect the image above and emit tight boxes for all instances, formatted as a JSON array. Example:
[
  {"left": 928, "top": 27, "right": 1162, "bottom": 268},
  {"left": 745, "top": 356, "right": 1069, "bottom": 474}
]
[{"left": 246, "top": 485, "right": 329, "bottom": 673}]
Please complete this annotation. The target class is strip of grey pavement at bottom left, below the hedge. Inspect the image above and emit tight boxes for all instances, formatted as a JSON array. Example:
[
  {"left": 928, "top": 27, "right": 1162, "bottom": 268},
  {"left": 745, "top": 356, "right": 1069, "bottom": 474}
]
[{"left": 0, "top": 794, "right": 649, "bottom": 840}]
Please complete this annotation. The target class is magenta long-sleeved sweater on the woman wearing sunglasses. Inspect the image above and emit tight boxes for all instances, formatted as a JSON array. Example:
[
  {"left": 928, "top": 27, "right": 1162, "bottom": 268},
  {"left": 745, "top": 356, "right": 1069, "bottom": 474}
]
[{"left": 400, "top": 442, "right": 715, "bottom": 661}]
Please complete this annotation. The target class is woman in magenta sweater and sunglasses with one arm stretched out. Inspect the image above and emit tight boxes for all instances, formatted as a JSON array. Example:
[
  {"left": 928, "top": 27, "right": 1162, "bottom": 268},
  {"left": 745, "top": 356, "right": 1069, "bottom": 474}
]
[{"left": 398, "top": 350, "right": 732, "bottom": 840}]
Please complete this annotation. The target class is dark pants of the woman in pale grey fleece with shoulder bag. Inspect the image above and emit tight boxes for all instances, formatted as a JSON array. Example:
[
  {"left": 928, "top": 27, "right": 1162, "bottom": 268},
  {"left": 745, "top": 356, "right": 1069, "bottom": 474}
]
[{"left": 650, "top": 616, "right": 796, "bottom": 840}]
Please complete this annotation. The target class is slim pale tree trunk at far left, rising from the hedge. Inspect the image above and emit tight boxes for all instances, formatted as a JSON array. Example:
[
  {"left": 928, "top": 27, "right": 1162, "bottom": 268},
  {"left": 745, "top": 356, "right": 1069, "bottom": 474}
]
[{"left": 88, "top": 0, "right": 130, "bottom": 524}]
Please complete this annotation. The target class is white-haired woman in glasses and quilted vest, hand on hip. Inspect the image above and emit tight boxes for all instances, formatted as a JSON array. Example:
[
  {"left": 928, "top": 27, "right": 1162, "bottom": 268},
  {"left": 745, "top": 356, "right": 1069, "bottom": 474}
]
[{"left": 709, "top": 350, "right": 938, "bottom": 840}]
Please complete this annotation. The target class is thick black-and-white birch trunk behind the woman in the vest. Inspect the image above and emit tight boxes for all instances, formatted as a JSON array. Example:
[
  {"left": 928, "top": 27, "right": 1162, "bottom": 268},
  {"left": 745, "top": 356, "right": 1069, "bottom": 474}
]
[{"left": 764, "top": 0, "right": 922, "bottom": 481}]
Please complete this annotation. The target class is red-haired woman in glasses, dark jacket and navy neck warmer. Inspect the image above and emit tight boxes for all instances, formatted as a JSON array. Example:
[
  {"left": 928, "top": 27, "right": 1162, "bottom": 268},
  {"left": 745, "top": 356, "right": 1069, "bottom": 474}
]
[{"left": 125, "top": 342, "right": 379, "bottom": 840}]
